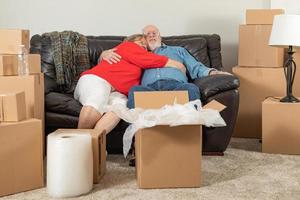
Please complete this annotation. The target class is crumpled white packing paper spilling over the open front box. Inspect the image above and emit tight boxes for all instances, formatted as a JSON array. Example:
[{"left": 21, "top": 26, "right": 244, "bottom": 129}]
[{"left": 105, "top": 100, "right": 226, "bottom": 157}]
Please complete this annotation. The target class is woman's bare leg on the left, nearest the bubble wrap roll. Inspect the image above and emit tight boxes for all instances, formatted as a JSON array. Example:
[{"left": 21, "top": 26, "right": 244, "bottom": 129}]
[{"left": 78, "top": 106, "right": 101, "bottom": 129}]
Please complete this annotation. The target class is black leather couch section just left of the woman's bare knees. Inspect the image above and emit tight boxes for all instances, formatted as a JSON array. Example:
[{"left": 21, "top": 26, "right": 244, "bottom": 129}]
[{"left": 45, "top": 92, "right": 82, "bottom": 117}]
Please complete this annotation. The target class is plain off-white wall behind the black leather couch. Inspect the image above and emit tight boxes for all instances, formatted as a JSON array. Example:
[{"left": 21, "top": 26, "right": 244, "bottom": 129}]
[{"left": 0, "top": 0, "right": 270, "bottom": 70}]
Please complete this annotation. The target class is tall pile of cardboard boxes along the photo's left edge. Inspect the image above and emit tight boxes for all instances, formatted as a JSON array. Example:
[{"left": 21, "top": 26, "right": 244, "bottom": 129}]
[{"left": 0, "top": 29, "right": 44, "bottom": 196}]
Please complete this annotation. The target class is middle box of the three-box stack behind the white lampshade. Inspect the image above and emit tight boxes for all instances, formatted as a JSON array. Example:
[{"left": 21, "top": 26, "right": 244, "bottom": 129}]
[{"left": 238, "top": 25, "right": 284, "bottom": 67}]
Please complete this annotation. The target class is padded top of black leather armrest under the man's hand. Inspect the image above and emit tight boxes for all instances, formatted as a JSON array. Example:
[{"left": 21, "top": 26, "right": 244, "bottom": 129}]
[{"left": 193, "top": 74, "right": 240, "bottom": 101}]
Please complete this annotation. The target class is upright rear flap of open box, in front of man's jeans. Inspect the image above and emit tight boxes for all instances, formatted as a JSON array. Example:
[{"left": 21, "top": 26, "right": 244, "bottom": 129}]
[{"left": 134, "top": 91, "right": 189, "bottom": 109}]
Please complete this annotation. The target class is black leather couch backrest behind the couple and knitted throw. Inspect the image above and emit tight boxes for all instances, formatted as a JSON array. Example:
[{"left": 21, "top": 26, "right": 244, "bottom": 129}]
[{"left": 30, "top": 34, "right": 223, "bottom": 79}]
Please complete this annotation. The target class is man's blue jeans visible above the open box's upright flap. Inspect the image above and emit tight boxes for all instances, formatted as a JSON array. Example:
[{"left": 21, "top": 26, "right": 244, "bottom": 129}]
[{"left": 127, "top": 80, "right": 200, "bottom": 109}]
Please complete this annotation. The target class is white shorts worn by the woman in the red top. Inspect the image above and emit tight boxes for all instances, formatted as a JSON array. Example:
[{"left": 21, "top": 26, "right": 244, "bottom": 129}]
[{"left": 74, "top": 74, "right": 127, "bottom": 114}]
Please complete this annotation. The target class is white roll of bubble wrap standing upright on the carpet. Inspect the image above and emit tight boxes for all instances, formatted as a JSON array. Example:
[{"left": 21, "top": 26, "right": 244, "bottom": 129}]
[{"left": 47, "top": 132, "right": 93, "bottom": 198}]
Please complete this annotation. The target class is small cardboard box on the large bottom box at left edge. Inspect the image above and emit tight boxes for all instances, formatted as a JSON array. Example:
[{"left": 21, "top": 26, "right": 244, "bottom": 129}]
[{"left": 0, "top": 92, "right": 26, "bottom": 122}]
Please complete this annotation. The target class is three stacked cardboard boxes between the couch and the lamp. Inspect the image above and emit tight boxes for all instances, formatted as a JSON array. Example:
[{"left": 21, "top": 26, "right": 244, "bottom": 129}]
[{"left": 233, "top": 9, "right": 286, "bottom": 138}]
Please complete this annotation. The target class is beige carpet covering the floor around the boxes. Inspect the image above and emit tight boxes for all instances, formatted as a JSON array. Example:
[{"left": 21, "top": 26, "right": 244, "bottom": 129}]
[{"left": 0, "top": 139, "right": 300, "bottom": 200}]
